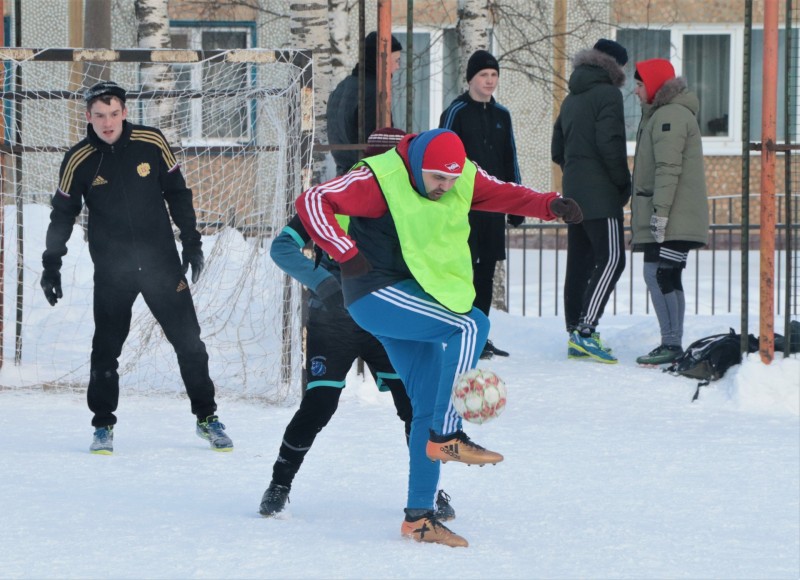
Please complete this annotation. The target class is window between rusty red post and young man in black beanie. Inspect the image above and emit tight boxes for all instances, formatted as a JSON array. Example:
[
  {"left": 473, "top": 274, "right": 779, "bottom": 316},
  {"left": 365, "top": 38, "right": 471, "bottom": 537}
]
[{"left": 392, "top": 28, "right": 463, "bottom": 133}]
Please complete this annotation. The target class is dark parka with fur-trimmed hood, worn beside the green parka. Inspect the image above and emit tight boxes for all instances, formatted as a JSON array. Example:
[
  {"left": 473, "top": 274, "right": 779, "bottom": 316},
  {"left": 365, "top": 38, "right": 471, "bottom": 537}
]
[{"left": 550, "top": 49, "right": 631, "bottom": 220}]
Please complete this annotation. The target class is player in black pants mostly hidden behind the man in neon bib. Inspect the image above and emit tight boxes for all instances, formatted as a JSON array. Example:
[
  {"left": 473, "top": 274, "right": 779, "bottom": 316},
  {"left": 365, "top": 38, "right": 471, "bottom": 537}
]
[{"left": 259, "top": 127, "right": 455, "bottom": 521}]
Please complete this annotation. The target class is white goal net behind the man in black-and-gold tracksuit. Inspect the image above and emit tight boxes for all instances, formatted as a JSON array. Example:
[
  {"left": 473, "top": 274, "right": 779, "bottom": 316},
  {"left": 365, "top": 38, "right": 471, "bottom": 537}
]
[{"left": 0, "top": 49, "right": 313, "bottom": 403}]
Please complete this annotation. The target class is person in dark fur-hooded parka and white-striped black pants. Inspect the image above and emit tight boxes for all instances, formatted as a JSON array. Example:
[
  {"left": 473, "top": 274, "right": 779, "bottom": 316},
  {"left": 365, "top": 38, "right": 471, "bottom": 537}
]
[{"left": 551, "top": 38, "right": 631, "bottom": 363}]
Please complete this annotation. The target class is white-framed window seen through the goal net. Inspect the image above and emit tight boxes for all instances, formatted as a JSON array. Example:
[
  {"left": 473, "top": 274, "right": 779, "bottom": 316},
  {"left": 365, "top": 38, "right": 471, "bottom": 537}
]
[{"left": 170, "top": 23, "right": 253, "bottom": 144}]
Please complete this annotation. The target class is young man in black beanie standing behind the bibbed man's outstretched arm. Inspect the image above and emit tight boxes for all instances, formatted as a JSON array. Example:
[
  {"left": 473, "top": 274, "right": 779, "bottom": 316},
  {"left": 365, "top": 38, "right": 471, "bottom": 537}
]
[{"left": 439, "top": 50, "right": 525, "bottom": 359}]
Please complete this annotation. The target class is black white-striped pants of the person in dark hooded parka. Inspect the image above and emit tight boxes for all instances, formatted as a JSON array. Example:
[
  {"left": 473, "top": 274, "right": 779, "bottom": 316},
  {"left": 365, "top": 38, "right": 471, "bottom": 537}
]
[{"left": 564, "top": 218, "right": 625, "bottom": 332}]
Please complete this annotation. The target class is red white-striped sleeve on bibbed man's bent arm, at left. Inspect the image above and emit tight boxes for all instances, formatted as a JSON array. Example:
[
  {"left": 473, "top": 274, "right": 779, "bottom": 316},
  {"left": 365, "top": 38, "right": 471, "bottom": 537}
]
[{"left": 294, "top": 166, "right": 389, "bottom": 262}]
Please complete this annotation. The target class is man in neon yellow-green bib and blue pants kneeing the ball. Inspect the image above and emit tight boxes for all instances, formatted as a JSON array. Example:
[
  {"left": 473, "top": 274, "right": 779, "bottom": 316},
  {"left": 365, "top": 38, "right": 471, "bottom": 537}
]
[{"left": 295, "top": 129, "right": 582, "bottom": 546}]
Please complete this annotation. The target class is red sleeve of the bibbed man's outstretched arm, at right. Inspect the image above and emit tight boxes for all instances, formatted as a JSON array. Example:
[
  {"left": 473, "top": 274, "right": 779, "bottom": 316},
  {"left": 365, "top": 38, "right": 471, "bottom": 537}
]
[{"left": 472, "top": 167, "right": 558, "bottom": 221}]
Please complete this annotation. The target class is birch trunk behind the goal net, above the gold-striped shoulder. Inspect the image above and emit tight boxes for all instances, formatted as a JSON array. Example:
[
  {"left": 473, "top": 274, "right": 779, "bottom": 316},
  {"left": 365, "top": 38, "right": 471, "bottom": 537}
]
[{"left": 134, "top": 0, "right": 178, "bottom": 143}]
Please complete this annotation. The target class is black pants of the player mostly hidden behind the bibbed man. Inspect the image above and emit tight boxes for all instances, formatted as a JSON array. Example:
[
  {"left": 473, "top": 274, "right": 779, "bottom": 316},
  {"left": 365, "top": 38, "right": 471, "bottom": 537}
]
[{"left": 272, "top": 308, "right": 412, "bottom": 487}]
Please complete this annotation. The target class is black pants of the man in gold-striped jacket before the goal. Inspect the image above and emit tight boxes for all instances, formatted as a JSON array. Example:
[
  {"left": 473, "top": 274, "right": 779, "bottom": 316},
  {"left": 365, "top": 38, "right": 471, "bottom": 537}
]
[{"left": 86, "top": 272, "right": 217, "bottom": 427}]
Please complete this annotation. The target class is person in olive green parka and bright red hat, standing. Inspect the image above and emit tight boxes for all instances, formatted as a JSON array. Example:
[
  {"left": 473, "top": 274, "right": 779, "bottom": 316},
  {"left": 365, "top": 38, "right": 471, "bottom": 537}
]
[{"left": 631, "top": 58, "right": 708, "bottom": 365}]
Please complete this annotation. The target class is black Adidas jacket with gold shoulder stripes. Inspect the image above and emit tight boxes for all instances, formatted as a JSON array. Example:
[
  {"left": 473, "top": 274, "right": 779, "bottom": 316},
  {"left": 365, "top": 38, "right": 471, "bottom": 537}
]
[{"left": 42, "top": 121, "right": 202, "bottom": 273}]
